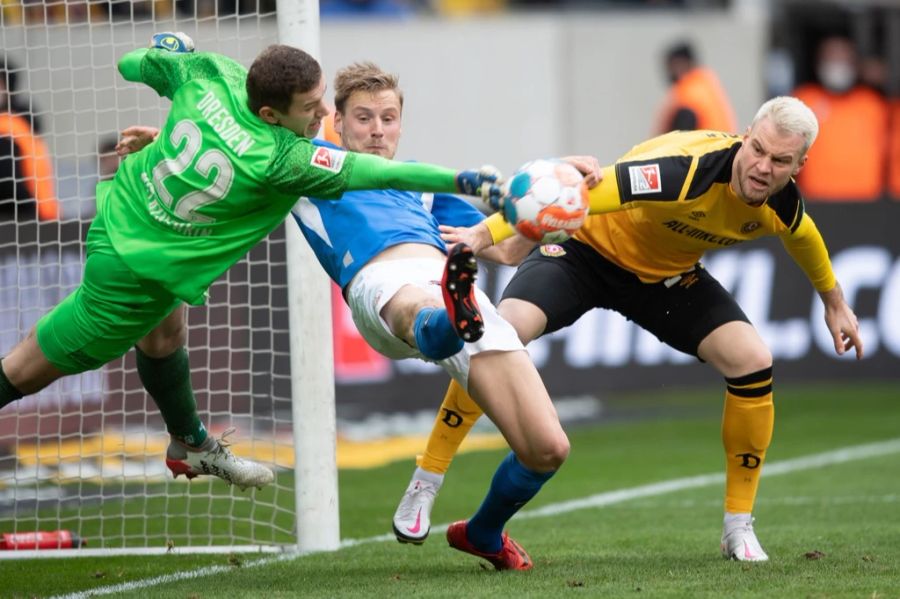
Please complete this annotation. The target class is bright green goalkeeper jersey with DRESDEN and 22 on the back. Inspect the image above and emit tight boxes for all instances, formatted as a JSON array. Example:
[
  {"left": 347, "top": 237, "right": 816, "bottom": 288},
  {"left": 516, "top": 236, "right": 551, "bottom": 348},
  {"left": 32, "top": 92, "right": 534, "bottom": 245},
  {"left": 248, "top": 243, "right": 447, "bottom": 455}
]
[{"left": 103, "top": 49, "right": 356, "bottom": 304}]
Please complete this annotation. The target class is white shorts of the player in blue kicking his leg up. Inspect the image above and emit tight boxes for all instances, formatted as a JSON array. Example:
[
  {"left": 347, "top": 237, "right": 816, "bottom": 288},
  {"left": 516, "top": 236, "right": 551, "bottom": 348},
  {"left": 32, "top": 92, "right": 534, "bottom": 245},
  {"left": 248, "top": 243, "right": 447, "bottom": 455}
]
[{"left": 347, "top": 258, "right": 525, "bottom": 390}]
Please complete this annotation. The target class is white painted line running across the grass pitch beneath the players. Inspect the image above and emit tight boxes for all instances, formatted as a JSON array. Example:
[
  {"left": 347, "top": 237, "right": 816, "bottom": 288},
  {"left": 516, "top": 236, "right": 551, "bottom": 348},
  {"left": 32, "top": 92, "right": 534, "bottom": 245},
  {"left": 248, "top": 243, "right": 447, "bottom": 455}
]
[{"left": 53, "top": 439, "right": 900, "bottom": 599}]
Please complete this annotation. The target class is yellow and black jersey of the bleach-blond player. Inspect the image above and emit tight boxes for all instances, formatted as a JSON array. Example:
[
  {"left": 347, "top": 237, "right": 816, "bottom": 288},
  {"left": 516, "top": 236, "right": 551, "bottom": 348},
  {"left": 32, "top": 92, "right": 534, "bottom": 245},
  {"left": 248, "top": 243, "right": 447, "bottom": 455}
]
[{"left": 487, "top": 131, "right": 835, "bottom": 291}]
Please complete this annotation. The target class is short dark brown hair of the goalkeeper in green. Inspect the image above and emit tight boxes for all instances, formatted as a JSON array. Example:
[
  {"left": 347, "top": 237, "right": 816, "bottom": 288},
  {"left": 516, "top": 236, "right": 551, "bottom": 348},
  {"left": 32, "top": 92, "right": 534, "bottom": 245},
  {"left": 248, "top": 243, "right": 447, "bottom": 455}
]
[{"left": 247, "top": 44, "right": 322, "bottom": 114}]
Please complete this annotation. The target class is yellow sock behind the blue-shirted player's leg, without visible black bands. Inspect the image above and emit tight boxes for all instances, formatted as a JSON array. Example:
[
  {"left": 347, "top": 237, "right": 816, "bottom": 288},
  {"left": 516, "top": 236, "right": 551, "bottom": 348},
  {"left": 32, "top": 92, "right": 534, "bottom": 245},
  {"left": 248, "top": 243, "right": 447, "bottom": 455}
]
[{"left": 416, "top": 381, "right": 483, "bottom": 474}]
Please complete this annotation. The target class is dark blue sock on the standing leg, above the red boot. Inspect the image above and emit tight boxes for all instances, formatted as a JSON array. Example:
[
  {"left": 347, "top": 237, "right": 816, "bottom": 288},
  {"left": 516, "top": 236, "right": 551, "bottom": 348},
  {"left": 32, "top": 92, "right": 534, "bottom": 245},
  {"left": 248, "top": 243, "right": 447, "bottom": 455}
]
[{"left": 466, "top": 452, "right": 556, "bottom": 553}]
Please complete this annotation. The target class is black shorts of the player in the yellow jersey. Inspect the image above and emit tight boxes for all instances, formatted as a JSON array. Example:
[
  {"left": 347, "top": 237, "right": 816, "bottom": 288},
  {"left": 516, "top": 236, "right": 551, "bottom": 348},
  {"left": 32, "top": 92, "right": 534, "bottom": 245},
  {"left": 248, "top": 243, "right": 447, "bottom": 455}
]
[{"left": 502, "top": 239, "right": 750, "bottom": 356}]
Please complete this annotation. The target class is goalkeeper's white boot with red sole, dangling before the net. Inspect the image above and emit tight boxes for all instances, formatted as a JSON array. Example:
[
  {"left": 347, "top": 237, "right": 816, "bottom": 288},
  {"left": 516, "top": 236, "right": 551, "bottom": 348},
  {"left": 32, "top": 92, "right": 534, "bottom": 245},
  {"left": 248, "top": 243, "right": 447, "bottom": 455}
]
[{"left": 166, "top": 428, "right": 275, "bottom": 491}]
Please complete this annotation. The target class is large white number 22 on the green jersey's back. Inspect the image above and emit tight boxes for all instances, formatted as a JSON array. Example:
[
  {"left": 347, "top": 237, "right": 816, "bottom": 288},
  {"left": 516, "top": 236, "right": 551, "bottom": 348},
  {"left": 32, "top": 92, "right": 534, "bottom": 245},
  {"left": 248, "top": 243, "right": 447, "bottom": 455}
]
[{"left": 153, "top": 119, "right": 234, "bottom": 223}]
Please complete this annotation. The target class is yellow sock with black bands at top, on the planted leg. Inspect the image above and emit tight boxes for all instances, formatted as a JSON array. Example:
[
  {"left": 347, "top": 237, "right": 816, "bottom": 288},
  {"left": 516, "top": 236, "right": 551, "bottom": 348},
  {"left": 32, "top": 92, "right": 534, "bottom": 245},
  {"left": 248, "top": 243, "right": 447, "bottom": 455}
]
[{"left": 722, "top": 367, "right": 775, "bottom": 513}]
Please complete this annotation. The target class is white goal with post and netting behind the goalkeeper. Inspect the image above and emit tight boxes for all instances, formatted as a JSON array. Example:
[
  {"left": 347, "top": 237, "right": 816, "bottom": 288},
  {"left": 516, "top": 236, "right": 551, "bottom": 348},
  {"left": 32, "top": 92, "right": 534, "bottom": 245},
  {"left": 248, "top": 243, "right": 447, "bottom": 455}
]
[{"left": 0, "top": 0, "right": 340, "bottom": 559}]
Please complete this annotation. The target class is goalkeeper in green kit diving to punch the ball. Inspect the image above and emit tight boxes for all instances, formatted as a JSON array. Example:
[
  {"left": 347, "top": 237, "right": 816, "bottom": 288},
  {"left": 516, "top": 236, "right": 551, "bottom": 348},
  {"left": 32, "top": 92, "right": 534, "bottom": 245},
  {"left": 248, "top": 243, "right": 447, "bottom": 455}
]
[{"left": 0, "top": 33, "right": 500, "bottom": 488}]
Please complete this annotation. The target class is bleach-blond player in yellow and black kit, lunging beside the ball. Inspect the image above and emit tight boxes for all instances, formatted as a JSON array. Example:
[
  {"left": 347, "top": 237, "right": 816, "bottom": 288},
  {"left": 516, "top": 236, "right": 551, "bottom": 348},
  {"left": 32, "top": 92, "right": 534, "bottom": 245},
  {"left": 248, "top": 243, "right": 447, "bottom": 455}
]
[{"left": 394, "top": 97, "right": 863, "bottom": 561}]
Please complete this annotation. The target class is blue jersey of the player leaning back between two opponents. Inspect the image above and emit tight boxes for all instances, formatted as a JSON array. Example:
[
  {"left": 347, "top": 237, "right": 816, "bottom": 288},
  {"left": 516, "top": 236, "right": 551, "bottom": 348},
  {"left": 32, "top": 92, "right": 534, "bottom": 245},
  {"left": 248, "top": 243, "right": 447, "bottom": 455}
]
[{"left": 292, "top": 141, "right": 484, "bottom": 289}]
